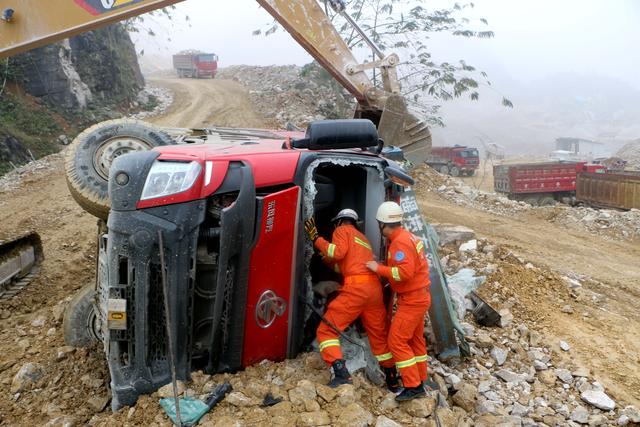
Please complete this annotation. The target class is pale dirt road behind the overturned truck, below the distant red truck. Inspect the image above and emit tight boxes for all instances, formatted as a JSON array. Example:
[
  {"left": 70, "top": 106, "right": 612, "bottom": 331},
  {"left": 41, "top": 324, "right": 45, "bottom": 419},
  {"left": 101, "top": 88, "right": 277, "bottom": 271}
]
[{"left": 149, "top": 77, "right": 267, "bottom": 128}]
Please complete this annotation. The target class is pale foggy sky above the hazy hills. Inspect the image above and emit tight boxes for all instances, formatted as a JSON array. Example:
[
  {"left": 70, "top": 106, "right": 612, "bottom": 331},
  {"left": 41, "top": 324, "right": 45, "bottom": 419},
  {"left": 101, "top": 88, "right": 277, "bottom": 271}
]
[{"left": 134, "top": 0, "right": 640, "bottom": 88}]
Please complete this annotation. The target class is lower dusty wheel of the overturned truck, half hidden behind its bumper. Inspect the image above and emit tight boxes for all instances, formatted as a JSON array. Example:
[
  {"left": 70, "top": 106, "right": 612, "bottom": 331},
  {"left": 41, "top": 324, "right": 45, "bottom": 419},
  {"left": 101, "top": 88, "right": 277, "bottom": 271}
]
[{"left": 62, "top": 285, "right": 102, "bottom": 347}]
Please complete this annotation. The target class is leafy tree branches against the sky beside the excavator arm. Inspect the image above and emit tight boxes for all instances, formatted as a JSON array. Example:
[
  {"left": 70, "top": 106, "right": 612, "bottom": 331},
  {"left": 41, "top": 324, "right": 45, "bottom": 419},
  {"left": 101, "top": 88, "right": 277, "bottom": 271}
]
[{"left": 254, "top": 0, "right": 513, "bottom": 125}]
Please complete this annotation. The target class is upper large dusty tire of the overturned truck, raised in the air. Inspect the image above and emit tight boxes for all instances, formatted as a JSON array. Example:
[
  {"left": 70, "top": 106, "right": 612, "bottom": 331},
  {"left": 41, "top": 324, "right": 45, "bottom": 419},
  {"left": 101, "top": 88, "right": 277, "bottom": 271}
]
[{"left": 65, "top": 119, "right": 175, "bottom": 220}]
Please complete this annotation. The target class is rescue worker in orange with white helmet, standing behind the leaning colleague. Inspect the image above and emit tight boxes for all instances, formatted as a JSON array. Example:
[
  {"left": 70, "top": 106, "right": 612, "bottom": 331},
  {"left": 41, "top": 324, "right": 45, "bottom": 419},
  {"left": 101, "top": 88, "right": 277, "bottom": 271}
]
[{"left": 367, "top": 202, "right": 431, "bottom": 401}]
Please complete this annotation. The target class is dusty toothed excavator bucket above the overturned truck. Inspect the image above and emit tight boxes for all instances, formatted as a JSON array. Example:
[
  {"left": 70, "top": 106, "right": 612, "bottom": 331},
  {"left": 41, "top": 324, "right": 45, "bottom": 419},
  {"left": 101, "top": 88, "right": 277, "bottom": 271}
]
[{"left": 378, "top": 95, "right": 431, "bottom": 165}]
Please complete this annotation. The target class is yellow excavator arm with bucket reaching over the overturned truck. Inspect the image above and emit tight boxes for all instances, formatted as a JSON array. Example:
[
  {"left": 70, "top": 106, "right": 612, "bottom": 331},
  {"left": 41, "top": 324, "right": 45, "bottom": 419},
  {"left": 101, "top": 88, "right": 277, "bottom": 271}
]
[{"left": 0, "top": 0, "right": 431, "bottom": 162}]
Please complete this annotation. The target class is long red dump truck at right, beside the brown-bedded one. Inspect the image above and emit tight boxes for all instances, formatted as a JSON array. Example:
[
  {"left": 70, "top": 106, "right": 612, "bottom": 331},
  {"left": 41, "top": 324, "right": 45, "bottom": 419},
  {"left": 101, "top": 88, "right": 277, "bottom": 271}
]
[{"left": 493, "top": 162, "right": 606, "bottom": 206}]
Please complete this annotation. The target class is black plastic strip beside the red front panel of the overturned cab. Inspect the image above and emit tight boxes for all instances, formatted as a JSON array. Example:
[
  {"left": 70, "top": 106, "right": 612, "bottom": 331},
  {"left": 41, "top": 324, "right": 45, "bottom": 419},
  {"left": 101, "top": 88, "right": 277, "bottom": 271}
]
[{"left": 206, "top": 162, "right": 256, "bottom": 373}]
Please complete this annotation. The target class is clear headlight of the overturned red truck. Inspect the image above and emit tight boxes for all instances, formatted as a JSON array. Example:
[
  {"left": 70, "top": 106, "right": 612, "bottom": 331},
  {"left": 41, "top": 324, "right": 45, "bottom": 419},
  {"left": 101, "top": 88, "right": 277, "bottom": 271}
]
[{"left": 140, "top": 160, "right": 201, "bottom": 200}]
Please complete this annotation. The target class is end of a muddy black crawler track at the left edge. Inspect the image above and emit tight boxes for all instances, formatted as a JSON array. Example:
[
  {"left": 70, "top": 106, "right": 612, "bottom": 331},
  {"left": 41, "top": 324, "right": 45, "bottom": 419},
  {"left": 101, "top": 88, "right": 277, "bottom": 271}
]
[{"left": 0, "top": 232, "right": 44, "bottom": 299}]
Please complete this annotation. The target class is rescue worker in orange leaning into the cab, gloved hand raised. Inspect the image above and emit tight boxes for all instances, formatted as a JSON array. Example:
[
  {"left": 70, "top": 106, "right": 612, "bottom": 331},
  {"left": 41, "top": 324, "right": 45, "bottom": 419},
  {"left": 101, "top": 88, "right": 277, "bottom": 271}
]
[{"left": 305, "top": 209, "right": 399, "bottom": 391}]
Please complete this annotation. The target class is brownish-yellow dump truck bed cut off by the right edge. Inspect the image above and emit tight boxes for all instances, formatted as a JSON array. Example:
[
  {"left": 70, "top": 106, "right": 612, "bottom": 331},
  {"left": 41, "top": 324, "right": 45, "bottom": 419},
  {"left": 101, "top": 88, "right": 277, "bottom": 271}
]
[{"left": 576, "top": 172, "right": 640, "bottom": 210}]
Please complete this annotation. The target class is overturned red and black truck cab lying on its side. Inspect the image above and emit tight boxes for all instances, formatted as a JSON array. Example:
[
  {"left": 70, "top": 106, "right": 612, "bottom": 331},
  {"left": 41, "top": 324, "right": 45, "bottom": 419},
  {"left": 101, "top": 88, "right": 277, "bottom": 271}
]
[{"left": 97, "top": 120, "right": 420, "bottom": 409}]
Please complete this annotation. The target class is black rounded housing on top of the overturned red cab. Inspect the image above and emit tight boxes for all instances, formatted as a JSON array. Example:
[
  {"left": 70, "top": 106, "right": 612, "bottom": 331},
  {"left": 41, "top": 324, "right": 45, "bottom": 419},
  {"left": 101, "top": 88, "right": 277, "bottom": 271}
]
[{"left": 291, "top": 119, "right": 381, "bottom": 150}]
